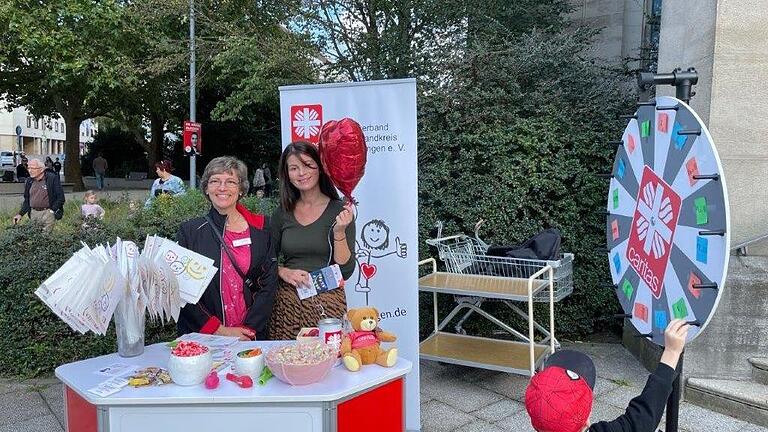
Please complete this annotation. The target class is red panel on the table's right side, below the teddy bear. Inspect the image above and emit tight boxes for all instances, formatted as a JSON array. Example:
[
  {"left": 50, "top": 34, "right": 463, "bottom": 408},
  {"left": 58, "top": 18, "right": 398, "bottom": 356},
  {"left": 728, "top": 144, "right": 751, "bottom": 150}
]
[{"left": 336, "top": 378, "right": 405, "bottom": 432}]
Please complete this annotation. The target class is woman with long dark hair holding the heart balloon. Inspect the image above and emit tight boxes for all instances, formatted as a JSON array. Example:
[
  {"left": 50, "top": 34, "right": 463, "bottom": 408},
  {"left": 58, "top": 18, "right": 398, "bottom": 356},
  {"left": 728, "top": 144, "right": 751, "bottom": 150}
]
[{"left": 270, "top": 141, "right": 355, "bottom": 340}]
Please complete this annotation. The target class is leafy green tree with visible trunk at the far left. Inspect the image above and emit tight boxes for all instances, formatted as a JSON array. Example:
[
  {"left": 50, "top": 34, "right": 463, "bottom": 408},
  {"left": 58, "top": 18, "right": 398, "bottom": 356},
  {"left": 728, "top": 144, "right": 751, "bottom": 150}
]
[{"left": 0, "top": 0, "right": 135, "bottom": 190}]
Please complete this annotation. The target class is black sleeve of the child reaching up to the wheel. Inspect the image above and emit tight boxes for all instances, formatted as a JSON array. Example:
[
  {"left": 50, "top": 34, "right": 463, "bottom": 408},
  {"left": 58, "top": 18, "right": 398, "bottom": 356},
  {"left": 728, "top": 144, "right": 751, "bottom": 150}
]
[{"left": 589, "top": 363, "right": 677, "bottom": 432}]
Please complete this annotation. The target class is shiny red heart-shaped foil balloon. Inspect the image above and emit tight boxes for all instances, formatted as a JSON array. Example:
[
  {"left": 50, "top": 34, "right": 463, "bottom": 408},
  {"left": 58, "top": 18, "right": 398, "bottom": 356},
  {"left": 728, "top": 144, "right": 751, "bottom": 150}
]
[{"left": 318, "top": 118, "right": 368, "bottom": 202}]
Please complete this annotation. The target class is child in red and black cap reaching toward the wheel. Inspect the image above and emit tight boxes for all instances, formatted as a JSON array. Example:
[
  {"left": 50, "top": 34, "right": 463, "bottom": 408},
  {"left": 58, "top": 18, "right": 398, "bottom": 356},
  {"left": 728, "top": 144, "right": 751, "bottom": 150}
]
[{"left": 525, "top": 320, "right": 690, "bottom": 432}]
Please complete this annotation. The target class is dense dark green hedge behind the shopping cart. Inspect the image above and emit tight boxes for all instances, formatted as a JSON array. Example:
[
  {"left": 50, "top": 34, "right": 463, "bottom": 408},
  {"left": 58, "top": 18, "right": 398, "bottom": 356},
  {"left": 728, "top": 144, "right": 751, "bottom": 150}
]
[{"left": 419, "top": 30, "right": 632, "bottom": 335}]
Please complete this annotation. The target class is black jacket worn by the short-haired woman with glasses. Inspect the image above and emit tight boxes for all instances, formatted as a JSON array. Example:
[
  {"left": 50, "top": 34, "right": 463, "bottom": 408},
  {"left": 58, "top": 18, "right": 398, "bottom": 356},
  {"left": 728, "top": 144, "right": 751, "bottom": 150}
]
[{"left": 176, "top": 208, "right": 277, "bottom": 339}]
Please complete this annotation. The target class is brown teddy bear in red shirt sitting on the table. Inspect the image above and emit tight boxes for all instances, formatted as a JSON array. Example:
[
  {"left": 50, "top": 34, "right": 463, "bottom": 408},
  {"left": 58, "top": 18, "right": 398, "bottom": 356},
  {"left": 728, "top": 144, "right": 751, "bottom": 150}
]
[{"left": 341, "top": 307, "right": 397, "bottom": 372}]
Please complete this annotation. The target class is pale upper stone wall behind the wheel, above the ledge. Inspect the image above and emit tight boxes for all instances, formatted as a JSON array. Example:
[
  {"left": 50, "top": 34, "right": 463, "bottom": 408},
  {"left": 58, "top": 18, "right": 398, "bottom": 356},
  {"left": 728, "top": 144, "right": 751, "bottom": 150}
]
[{"left": 657, "top": 0, "right": 768, "bottom": 248}]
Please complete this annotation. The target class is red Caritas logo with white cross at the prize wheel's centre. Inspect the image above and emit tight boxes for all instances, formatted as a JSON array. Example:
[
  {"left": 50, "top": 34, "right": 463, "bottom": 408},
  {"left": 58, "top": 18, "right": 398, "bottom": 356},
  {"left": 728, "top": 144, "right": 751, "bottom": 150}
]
[{"left": 627, "top": 166, "right": 680, "bottom": 299}]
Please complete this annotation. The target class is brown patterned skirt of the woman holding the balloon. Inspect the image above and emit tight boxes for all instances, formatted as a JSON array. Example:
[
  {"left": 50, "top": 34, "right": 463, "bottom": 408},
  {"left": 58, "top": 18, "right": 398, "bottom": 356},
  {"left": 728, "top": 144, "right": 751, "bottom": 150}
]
[{"left": 269, "top": 280, "right": 347, "bottom": 340}]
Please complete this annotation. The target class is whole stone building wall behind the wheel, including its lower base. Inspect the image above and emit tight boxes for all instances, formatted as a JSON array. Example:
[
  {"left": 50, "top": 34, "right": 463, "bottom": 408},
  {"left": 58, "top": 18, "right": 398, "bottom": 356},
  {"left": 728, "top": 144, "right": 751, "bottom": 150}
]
[{"left": 624, "top": 0, "right": 768, "bottom": 379}]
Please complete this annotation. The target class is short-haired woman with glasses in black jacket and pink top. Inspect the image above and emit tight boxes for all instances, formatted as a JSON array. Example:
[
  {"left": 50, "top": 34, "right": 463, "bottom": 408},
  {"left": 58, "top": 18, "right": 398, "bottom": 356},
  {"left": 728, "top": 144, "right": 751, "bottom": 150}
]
[{"left": 176, "top": 156, "right": 277, "bottom": 340}]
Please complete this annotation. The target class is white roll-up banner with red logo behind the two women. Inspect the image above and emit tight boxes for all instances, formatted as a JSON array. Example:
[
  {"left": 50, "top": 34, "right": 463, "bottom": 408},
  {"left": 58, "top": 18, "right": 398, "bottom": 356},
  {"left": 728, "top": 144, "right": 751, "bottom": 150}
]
[{"left": 280, "top": 79, "right": 421, "bottom": 430}]
